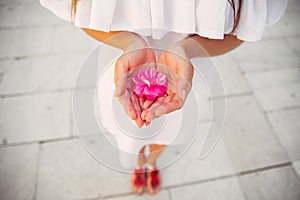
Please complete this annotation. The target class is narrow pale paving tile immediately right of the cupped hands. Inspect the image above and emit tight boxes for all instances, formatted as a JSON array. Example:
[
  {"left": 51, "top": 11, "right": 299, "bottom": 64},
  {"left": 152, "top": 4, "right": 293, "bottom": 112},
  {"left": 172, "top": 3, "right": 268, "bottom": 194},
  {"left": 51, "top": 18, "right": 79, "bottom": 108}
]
[{"left": 213, "top": 55, "right": 251, "bottom": 95}]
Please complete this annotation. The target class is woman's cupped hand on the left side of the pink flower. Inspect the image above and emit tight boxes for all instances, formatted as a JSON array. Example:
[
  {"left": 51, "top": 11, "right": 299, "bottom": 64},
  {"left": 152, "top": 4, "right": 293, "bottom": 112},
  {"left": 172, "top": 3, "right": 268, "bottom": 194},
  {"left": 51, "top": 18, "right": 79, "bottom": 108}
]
[{"left": 114, "top": 39, "right": 156, "bottom": 127}]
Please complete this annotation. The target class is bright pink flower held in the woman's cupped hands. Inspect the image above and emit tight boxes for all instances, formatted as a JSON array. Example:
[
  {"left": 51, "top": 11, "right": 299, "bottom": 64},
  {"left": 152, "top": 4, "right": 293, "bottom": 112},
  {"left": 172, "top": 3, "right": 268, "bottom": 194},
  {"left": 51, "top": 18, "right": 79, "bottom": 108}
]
[{"left": 133, "top": 67, "right": 168, "bottom": 100}]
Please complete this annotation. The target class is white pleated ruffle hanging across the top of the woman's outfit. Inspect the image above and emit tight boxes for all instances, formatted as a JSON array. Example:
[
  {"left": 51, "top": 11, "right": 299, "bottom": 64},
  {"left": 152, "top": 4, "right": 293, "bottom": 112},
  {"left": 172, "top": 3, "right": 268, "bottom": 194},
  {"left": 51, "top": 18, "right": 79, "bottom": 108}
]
[{"left": 40, "top": 0, "right": 288, "bottom": 41}]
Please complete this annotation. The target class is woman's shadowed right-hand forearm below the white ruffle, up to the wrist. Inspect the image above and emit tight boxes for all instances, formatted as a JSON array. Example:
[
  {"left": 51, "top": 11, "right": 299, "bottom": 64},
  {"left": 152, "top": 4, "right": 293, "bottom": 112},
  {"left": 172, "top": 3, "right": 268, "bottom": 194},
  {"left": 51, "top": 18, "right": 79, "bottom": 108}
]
[{"left": 179, "top": 35, "right": 243, "bottom": 58}]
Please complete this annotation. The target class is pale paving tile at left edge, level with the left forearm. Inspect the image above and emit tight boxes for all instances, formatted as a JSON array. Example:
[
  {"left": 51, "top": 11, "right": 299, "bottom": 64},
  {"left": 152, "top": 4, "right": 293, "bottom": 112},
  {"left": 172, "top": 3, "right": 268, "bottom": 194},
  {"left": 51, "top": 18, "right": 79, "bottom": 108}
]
[{"left": 0, "top": 27, "right": 53, "bottom": 57}]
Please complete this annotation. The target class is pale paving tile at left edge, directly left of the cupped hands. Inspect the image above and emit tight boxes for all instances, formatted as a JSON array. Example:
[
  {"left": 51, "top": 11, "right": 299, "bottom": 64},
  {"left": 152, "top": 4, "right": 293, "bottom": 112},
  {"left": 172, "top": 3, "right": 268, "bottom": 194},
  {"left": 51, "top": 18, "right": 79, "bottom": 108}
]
[{"left": 0, "top": 53, "right": 86, "bottom": 94}]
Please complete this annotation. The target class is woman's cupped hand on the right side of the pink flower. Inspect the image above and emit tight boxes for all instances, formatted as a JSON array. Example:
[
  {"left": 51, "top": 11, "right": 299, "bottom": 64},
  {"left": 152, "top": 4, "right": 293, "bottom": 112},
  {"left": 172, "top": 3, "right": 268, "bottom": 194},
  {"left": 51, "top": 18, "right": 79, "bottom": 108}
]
[{"left": 141, "top": 43, "right": 194, "bottom": 122}]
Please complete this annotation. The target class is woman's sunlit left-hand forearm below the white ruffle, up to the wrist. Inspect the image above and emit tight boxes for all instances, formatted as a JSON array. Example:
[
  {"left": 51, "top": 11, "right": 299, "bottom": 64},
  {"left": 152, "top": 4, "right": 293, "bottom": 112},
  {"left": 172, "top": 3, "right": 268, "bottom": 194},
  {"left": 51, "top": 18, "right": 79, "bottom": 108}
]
[{"left": 82, "top": 28, "right": 146, "bottom": 51}]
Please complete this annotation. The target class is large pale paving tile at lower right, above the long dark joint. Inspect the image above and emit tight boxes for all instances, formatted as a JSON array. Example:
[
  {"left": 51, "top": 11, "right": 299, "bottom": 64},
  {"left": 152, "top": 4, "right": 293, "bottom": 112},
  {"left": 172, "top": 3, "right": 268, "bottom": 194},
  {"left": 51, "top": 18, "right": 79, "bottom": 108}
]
[{"left": 222, "top": 96, "right": 288, "bottom": 171}]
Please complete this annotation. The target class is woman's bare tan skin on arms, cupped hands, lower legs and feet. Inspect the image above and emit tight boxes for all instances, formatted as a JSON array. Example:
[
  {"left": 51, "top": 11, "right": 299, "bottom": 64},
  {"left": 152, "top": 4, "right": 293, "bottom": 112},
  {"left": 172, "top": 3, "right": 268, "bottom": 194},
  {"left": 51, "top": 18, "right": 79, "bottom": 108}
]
[{"left": 83, "top": 28, "right": 243, "bottom": 194}]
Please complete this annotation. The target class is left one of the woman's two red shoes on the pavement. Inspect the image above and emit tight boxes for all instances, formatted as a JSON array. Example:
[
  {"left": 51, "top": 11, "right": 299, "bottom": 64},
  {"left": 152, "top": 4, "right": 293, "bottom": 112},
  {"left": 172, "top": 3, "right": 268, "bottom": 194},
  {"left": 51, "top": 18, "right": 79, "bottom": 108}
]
[{"left": 131, "top": 166, "right": 146, "bottom": 194}]
